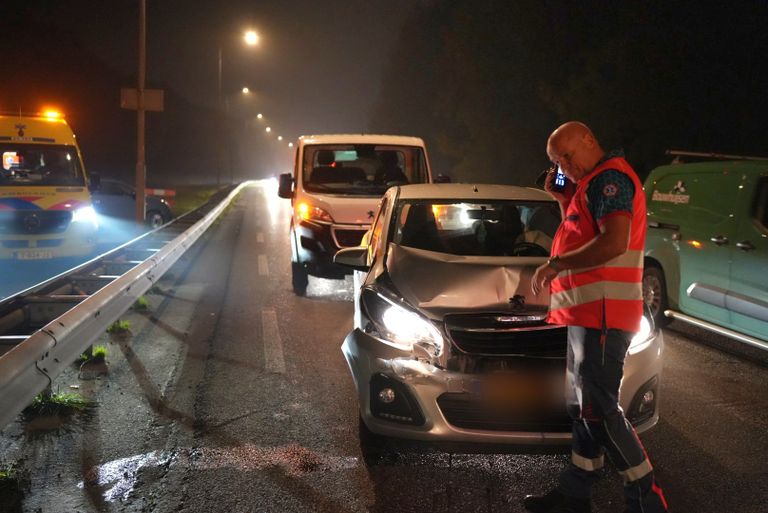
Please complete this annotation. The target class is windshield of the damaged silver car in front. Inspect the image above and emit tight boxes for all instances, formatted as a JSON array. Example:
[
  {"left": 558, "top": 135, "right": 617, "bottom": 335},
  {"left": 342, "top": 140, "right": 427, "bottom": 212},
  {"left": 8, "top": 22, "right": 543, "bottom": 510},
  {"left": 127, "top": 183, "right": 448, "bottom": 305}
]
[{"left": 390, "top": 199, "right": 560, "bottom": 256}]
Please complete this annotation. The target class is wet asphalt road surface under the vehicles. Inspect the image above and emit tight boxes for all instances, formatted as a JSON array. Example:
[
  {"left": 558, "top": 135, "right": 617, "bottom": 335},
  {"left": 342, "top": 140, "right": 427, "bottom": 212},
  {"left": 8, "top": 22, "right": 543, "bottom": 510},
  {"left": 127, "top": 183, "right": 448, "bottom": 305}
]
[{"left": 0, "top": 182, "right": 768, "bottom": 513}]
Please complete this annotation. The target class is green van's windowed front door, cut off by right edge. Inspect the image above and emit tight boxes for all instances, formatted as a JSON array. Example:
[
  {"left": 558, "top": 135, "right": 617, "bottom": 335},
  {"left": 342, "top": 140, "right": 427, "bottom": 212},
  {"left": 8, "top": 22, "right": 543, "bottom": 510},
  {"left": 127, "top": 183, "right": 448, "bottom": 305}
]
[{"left": 728, "top": 171, "right": 768, "bottom": 340}]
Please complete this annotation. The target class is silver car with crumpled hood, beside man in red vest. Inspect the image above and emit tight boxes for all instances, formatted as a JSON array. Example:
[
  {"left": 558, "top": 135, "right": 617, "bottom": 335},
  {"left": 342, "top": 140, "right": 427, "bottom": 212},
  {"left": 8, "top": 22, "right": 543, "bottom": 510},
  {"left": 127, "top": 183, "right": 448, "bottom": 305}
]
[{"left": 335, "top": 184, "right": 663, "bottom": 445}]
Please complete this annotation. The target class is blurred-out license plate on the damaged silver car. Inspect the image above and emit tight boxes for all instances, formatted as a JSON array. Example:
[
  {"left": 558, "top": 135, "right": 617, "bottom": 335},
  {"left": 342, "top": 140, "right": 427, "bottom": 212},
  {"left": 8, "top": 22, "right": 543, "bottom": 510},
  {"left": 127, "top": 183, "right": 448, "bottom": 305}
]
[{"left": 476, "top": 373, "right": 563, "bottom": 410}]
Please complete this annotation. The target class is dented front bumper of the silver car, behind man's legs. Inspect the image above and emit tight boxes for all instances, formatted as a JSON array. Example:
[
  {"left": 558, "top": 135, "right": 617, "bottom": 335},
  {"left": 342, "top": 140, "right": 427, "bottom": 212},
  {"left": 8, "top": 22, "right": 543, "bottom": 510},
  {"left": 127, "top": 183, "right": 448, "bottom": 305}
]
[{"left": 342, "top": 329, "right": 663, "bottom": 445}]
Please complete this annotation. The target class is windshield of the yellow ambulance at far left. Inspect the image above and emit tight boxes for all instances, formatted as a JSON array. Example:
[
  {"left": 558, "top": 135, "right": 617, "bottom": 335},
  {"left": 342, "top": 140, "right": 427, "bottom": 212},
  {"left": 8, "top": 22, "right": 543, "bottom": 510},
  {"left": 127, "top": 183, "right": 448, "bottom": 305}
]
[{"left": 0, "top": 144, "right": 85, "bottom": 186}]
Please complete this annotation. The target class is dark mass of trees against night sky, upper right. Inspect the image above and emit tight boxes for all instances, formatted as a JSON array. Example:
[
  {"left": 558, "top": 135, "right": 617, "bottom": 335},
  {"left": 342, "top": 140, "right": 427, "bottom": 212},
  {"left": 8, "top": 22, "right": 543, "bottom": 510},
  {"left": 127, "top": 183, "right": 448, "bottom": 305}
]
[{"left": 370, "top": 0, "right": 768, "bottom": 185}]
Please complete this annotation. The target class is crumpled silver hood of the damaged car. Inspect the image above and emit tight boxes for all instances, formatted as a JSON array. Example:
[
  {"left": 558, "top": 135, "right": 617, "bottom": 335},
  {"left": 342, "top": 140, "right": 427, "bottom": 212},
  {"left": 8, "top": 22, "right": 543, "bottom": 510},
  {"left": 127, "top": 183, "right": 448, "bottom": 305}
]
[{"left": 387, "top": 244, "right": 549, "bottom": 318}]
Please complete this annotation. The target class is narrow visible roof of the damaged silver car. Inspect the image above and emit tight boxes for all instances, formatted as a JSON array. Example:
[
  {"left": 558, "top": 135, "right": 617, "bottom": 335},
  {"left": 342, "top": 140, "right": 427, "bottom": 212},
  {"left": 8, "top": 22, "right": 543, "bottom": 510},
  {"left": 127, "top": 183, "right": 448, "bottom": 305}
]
[{"left": 399, "top": 183, "right": 554, "bottom": 201}]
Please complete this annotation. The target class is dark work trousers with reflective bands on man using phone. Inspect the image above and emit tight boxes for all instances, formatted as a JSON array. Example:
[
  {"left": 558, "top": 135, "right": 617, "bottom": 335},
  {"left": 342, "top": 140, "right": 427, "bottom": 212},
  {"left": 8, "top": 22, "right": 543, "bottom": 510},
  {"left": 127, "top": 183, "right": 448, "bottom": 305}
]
[{"left": 558, "top": 326, "right": 667, "bottom": 513}]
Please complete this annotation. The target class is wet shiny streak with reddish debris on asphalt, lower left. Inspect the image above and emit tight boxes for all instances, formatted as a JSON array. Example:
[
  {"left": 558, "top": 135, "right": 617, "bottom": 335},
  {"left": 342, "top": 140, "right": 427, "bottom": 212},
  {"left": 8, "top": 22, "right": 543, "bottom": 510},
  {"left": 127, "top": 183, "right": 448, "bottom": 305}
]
[{"left": 78, "top": 444, "right": 358, "bottom": 502}]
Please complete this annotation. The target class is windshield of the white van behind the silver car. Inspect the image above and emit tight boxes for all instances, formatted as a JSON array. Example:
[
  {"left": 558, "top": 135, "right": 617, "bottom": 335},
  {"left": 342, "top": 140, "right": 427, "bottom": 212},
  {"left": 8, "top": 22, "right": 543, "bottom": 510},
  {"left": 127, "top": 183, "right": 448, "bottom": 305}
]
[{"left": 302, "top": 144, "right": 427, "bottom": 196}]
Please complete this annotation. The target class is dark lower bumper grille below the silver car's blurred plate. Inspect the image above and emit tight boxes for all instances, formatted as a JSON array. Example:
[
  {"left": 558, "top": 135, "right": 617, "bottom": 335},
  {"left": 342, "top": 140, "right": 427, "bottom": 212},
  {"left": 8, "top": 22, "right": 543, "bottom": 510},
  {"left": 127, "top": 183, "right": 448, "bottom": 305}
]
[{"left": 437, "top": 392, "right": 571, "bottom": 433}]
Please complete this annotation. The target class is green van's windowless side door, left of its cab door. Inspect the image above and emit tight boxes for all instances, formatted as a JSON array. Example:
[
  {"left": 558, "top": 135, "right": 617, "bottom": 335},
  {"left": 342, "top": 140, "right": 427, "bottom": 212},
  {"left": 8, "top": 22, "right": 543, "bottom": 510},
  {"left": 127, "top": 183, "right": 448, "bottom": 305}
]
[{"left": 680, "top": 166, "right": 739, "bottom": 325}]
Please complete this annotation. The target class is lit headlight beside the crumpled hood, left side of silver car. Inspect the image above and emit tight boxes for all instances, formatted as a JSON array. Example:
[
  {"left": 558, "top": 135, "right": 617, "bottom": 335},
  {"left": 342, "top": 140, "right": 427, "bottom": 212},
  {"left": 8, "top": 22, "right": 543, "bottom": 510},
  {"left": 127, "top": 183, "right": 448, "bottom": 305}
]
[{"left": 360, "top": 289, "right": 443, "bottom": 357}]
